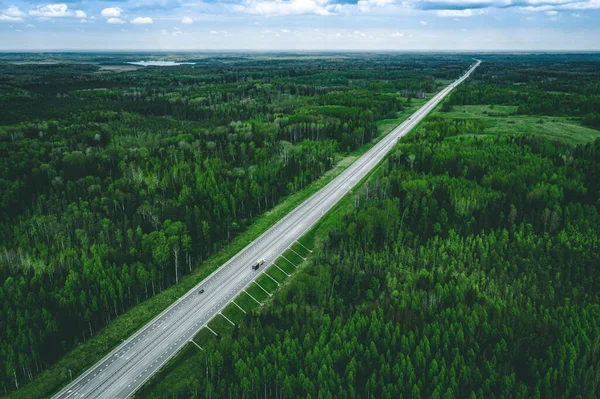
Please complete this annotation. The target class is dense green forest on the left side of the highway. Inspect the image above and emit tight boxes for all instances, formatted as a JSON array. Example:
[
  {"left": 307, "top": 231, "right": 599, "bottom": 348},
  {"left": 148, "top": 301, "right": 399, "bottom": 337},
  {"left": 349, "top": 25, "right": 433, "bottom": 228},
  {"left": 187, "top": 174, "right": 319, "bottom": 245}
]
[{"left": 0, "top": 53, "right": 471, "bottom": 394}]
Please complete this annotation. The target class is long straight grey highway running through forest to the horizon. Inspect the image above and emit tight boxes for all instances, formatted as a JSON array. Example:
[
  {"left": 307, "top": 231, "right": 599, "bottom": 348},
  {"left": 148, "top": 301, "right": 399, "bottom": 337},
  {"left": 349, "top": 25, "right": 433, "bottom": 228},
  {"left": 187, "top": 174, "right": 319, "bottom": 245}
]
[{"left": 54, "top": 60, "right": 481, "bottom": 399}]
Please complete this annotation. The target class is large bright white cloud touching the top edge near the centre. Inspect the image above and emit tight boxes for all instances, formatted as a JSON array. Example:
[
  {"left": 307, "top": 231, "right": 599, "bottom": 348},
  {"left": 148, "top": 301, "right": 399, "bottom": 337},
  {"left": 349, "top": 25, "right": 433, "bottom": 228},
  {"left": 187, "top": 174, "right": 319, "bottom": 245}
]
[{"left": 233, "top": 0, "right": 335, "bottom": 16}]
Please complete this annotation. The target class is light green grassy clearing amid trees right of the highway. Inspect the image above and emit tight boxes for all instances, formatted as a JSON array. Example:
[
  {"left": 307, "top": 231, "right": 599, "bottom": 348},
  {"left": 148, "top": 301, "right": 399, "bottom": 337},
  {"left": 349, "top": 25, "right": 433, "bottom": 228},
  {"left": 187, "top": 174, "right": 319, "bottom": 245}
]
[{"left": 435, "top": 105, "right": 600, "bottom": 145}]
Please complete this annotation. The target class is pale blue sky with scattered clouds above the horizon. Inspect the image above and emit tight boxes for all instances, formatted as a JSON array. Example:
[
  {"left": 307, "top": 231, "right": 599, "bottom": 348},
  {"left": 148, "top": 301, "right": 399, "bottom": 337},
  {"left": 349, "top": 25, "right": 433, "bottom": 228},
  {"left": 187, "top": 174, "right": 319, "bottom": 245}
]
[{"left": 0, "top": 0, "right": 600, "bottom": 51}]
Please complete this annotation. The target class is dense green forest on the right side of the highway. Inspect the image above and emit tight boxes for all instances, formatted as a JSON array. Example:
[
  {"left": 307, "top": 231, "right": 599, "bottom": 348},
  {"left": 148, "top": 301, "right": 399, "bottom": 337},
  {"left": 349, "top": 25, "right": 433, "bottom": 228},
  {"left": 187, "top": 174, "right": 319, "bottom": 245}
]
[{"left": 141, "top": 55, "right": 600, "bottom": 399}]
